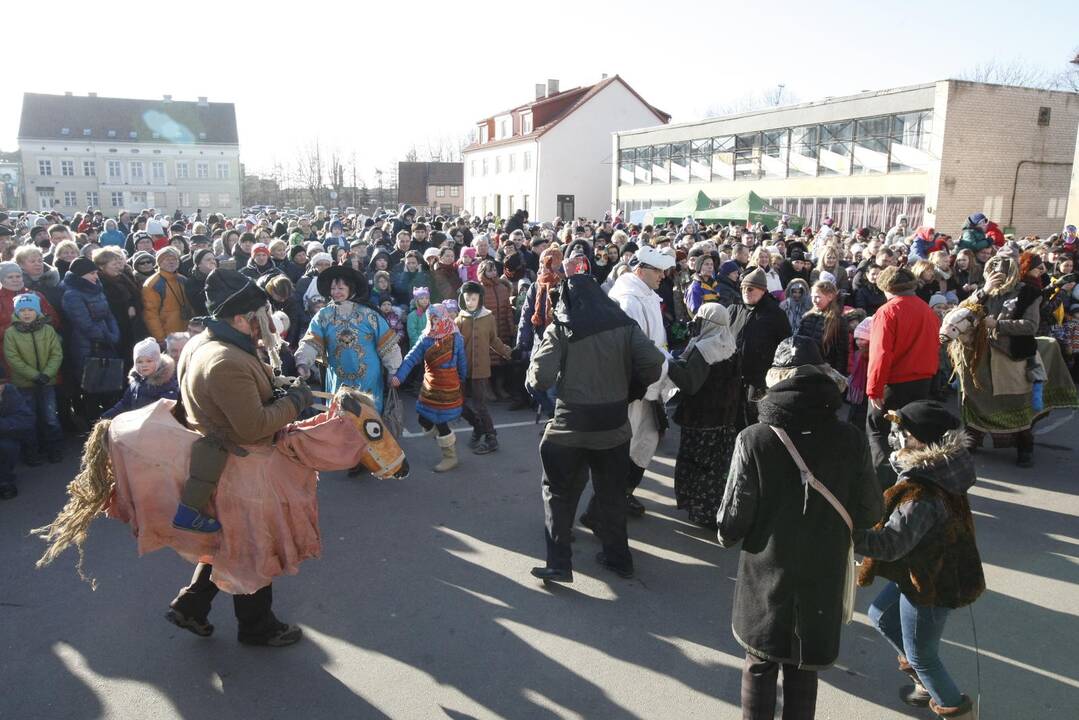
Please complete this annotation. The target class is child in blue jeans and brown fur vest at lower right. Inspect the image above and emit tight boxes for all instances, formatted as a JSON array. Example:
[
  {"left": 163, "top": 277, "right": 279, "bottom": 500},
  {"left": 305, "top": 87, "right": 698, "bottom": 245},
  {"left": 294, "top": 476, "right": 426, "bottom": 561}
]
[{"left": 853, "top": 400, "right": 985, "bottom": 720}]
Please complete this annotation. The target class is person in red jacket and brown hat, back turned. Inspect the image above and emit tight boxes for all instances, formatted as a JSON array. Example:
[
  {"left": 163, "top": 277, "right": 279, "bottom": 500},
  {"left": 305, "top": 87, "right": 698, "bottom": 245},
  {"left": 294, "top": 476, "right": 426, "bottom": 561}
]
[{"left": 865, "top": 267, "right": 940, "bottom": 489}]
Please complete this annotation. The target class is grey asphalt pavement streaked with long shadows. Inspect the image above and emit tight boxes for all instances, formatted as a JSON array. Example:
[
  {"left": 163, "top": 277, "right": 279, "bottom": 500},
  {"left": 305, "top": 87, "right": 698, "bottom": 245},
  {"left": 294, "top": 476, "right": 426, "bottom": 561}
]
[{"left": 0, "top": 405, "right": 1079, "bottom": 720}]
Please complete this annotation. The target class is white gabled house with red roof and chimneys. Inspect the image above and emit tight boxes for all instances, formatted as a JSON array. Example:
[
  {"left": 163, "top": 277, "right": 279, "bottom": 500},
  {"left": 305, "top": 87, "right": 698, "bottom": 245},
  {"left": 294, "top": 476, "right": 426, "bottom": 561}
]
[{"left": 464, "top": 76, "right": 670, "bottom": 220}]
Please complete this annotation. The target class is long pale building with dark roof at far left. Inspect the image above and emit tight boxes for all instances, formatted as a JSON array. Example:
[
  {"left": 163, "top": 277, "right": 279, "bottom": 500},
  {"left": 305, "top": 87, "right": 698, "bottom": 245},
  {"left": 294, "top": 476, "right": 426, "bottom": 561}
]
[{"left": 18, "top": 93, "right": 241, "bottom": 216}]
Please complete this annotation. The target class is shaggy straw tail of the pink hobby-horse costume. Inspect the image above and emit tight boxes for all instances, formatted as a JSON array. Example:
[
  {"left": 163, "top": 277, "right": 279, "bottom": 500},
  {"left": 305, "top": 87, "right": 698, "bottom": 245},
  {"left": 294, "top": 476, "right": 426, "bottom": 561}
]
[{"left": 30, "top": 420, "right": 117, "bottom": 589}]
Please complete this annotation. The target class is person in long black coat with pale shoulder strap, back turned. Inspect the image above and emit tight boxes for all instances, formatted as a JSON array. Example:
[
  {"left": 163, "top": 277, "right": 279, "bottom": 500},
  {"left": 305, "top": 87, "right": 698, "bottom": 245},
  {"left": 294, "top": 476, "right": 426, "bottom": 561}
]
[{"left": 716, "top": 365, "right": 882, "bottom": 720}]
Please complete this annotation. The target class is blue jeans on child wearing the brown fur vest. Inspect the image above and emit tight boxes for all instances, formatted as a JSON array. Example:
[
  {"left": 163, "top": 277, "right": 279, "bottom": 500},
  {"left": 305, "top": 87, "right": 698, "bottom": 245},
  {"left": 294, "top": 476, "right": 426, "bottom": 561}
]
[{"left": 869, "top": 583, "right": 962, "bottom": 707}]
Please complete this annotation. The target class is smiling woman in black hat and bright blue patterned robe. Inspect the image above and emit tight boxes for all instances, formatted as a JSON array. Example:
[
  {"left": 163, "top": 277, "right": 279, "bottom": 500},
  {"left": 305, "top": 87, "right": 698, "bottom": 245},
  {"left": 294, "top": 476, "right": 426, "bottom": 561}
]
[{"left": 296, "top": 266, "right": 401, "bottom": 413}]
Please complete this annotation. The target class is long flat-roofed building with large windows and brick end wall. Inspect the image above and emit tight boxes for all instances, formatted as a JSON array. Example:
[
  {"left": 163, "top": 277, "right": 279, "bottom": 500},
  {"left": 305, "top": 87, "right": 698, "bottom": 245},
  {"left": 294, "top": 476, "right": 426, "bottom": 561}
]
[{"left": 612, "top": 80, "right": 1079, "bottom": 235}]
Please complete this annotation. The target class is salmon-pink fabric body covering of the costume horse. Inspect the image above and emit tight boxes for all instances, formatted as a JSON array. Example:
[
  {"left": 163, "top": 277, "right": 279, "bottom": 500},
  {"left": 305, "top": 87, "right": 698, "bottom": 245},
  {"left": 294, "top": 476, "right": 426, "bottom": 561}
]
[{"left": 106, "top": 400, "right": 367, "bottom": 594}]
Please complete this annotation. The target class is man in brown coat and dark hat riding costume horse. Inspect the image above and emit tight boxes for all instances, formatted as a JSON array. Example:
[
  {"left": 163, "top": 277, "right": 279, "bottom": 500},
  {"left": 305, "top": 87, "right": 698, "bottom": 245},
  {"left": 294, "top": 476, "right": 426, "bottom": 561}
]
[{"left": 165, "top": 270, "right": 312, "bottom": 647}]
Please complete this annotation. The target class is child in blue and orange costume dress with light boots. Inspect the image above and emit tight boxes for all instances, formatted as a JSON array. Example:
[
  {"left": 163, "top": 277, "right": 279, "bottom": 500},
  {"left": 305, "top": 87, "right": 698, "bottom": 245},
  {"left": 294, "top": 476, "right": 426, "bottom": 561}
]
[{"left": 390, "top": 304, "right": 468, "bottom": 473}]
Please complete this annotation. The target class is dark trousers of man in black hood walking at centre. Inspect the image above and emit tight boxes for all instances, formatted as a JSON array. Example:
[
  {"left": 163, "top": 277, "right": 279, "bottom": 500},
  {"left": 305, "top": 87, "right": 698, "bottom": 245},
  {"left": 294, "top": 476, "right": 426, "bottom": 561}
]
[{"left": 540, "top": 438, "right": 633, "bottom": 569}]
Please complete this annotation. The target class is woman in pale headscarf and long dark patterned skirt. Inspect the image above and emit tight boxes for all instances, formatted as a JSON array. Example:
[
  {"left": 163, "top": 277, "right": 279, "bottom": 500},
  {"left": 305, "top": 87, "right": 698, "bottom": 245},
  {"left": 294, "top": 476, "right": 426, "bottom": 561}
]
[{"left": 669, "top": 302, "right": 741, "bottom": 529}]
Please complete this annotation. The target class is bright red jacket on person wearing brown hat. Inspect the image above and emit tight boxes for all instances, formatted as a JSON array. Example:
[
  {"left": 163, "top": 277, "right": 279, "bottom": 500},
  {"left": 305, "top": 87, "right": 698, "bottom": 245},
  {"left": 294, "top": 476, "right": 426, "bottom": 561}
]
[{"left": 865, "top": 295, "right": 941, "bottom": 399}]
